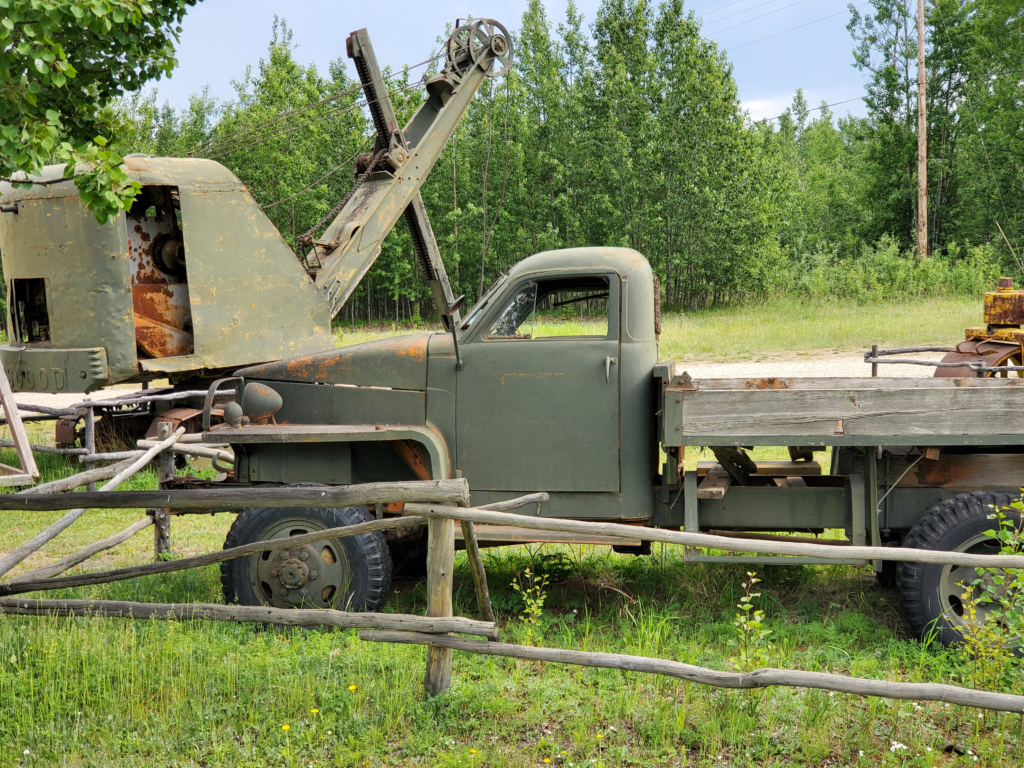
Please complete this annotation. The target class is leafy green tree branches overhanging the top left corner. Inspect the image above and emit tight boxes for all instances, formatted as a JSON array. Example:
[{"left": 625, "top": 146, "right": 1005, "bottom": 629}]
[{"left": 0, "top": 0, "right": 197, "bottom": 223}]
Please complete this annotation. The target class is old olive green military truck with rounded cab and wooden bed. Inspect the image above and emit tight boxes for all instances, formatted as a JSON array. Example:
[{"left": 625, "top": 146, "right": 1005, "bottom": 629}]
[{"left": 206, "top": 243, "right": 1024, "bottom": 641}]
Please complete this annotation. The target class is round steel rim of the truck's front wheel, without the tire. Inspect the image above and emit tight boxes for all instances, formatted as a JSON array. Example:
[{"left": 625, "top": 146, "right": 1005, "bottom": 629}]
[{"left": 247, "top": 516, "right": 351, "bottom": 608}]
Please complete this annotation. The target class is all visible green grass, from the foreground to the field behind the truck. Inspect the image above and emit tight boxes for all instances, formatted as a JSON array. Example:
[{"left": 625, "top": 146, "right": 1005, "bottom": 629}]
[{"left": 0, "top": 301, "right": 1024, "bottom": 768}]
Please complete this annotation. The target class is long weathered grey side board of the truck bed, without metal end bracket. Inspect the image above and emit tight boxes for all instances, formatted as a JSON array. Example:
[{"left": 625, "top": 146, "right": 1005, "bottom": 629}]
[{"left": 666, "top": 387, "right": 1024, "bottom": 444}]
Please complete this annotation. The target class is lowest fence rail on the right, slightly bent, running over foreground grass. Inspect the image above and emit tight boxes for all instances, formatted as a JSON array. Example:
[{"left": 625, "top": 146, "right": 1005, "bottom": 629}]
[{"left": 359, "top": 630, "right": 1024, "bottom": 714}]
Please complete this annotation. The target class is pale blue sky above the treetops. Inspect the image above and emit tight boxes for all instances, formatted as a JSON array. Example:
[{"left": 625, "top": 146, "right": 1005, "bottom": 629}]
[{"left": 157, "top": 0, "right": 866, "bottom": 119}]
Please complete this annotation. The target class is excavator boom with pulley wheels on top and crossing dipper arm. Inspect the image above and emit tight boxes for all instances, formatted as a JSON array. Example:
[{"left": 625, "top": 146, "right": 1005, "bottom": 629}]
[{"left": 306, "top": 19, "right": 512, "bottom": 329}]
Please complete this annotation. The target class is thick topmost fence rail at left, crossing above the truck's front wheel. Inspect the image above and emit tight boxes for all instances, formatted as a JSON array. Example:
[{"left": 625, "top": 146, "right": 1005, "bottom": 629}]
[{"left": 0, "top": 479, "right": 469, "bottom": 512}]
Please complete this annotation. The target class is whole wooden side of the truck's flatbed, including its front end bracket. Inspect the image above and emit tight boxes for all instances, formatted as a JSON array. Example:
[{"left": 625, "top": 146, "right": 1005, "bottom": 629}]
[{"left": 660, "top": 366, "right": 1024, "bottom": 446}]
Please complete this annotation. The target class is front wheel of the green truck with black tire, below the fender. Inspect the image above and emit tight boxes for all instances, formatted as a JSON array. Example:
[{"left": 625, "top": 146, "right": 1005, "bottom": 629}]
[{"left": 220, "top": 507, "right": 391, "bottom": 611}]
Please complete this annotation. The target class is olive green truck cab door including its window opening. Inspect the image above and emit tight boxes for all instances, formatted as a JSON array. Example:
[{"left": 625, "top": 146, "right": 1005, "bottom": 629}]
[{"left": 456, "top": 272, "right": 620, "bottom": 493}]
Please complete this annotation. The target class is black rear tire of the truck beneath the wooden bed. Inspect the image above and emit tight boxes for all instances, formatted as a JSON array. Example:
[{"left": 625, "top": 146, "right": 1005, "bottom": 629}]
[{"left": 896, "top": 490, "right": 1020, "bottom": 645}]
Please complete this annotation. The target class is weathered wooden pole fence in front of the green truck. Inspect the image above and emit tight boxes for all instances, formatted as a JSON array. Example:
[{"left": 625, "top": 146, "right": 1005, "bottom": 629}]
[{"left": 0, "top": 432, "right": 1024, "bottom": 714}]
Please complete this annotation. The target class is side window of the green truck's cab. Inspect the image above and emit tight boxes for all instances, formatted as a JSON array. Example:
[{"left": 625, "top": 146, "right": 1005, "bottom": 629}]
[{"left": 487, "top": 275, "right": 608, "bottom": 339}]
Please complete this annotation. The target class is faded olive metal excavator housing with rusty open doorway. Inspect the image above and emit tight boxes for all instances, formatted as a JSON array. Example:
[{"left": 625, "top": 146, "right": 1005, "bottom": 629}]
[{"left": 0, "top": 157, "right": 333, "bottom": 391}]
